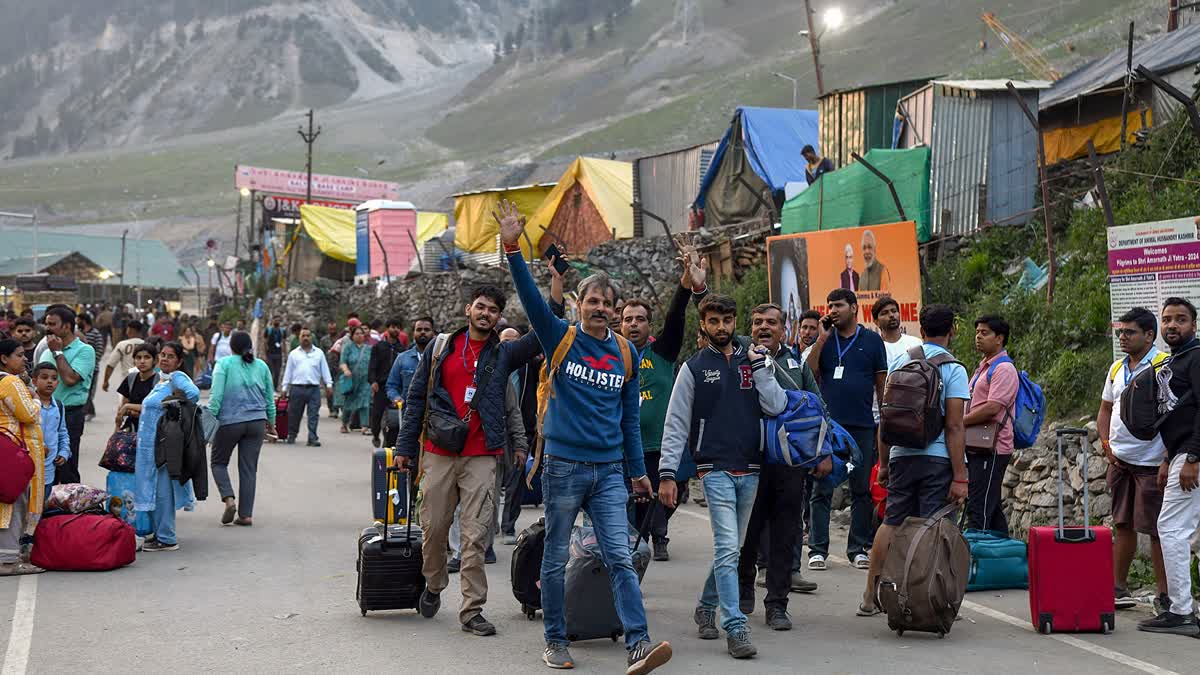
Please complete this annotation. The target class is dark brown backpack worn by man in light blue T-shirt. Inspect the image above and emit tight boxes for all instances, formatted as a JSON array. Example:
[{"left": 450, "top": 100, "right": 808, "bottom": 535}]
[{"left": 880, "top": 347, "right": 961, "bottom": 449}]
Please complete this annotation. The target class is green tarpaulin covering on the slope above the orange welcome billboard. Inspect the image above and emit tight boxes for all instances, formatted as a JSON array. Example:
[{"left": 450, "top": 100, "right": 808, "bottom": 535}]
[{"left": 782, "top": 148, "right": 929, "bottom": 241}]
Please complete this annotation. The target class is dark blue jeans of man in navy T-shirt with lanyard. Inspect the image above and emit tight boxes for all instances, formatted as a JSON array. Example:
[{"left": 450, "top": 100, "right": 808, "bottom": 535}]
[{"left": 809, "top": 426, "right": 878, "bottom": 561}]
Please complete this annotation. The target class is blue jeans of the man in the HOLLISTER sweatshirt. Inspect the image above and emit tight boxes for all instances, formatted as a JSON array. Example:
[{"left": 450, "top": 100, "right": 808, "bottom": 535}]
[{"left": 541, "top": 456, "right": 648, "bottom": 649}]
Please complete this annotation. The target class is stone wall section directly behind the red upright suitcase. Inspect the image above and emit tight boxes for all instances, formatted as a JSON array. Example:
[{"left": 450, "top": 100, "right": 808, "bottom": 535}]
[{"left": 1001, "top": 422, "right": 1112, "bottom": 539}]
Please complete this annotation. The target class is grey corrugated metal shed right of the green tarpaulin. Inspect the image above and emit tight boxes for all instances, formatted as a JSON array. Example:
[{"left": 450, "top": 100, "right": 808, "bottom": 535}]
[{"left": 896, "top": 80, "right": 1049, "bottom": 237}]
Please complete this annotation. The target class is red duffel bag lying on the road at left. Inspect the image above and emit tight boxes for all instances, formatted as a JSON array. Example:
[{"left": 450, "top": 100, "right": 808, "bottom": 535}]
[{"left": 30, "top": 513, "right": 137, "bottom": 572}]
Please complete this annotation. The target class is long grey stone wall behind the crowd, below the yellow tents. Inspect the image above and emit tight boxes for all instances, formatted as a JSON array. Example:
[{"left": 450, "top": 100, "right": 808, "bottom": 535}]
[{"left": 264, "top": 225, "right": 767, "bottom": 333}]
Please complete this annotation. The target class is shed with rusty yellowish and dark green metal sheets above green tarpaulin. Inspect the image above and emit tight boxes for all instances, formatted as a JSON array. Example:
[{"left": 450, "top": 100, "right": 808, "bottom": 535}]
[{"left": 817, "top": 77, "right": 930, "bottom": 167}]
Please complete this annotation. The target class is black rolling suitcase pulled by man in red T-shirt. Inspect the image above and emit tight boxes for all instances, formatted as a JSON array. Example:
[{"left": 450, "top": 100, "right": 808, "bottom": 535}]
[{"left": 354, "top": 470, "right": 425, "bottom": 616}]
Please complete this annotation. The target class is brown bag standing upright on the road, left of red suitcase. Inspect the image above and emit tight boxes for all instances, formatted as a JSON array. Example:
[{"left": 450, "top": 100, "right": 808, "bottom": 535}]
[{"left": 876, "top": 504, "right": 971, "bottom": 637}]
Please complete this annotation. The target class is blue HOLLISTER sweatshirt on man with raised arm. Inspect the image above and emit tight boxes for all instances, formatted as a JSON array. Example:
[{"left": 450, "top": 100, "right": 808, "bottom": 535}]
[{"left": 509, "top": 253, "right": 646, "bottom": 478}]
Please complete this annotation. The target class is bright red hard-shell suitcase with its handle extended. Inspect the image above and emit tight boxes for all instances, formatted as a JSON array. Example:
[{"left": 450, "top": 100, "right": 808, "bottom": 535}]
[{"left": 1030, "top": 429, "right": 1116, "bottom": 634}]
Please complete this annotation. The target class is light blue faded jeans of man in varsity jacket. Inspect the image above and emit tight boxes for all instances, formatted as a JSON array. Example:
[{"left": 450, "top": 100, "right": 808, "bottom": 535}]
[{"left": 700, "top": 471, "right": 758, "bottom": 632}]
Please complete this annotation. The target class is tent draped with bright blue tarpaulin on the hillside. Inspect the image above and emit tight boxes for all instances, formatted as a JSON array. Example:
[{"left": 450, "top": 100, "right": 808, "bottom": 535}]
[{"left": 696, "top": 107, "right": 821, "bottom": 225}]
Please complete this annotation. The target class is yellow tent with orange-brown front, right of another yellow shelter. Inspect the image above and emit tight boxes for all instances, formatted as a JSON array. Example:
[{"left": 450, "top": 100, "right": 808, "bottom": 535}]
[{"left": 526, "top": 157, "right": 634, "bottom": 256}]
